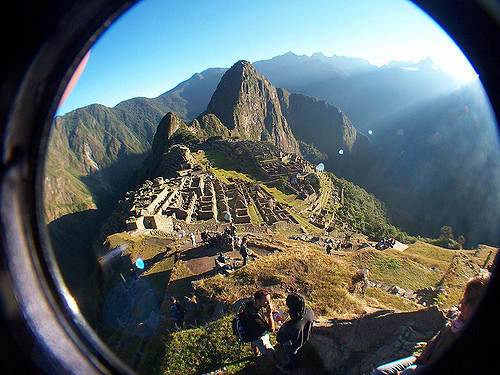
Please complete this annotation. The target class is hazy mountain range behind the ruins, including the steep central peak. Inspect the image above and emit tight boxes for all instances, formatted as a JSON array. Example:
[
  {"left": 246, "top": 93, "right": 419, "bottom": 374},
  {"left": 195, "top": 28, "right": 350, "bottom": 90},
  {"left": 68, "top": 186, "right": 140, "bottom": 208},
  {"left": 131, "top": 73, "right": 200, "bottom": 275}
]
[{"left": 45, "top": 53, "right": 500, "bottom": 247}]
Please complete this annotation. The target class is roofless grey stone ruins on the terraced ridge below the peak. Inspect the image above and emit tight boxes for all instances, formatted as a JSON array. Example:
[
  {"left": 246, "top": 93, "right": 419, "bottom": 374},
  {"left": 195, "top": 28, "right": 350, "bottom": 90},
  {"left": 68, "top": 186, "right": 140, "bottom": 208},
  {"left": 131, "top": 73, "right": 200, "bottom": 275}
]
[{"left": 122, "top": 140, "right": 336, "bottom": 232}]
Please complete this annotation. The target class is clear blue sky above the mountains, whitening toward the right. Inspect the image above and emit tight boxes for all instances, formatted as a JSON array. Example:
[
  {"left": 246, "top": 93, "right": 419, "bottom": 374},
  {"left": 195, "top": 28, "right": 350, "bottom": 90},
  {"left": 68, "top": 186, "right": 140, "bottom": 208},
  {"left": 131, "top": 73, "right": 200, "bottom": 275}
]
[{"left": 58, "top": 0, "right": 474, "bottom": 114}]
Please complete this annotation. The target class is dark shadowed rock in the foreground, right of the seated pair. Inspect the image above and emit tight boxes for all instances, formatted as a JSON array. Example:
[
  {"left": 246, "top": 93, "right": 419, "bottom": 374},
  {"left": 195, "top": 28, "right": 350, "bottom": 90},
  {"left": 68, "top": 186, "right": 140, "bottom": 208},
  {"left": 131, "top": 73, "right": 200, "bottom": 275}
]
[{"left": 311, "top": 307, "right": 446, "bottom": 375}]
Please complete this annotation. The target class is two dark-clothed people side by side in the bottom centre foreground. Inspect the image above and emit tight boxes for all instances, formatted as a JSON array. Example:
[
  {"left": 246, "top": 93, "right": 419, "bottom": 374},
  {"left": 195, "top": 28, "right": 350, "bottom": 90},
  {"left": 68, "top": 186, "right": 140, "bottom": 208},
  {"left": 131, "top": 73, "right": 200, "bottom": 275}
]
[{"left": 238, "top": 290, "right": 314, "bottom": 374}]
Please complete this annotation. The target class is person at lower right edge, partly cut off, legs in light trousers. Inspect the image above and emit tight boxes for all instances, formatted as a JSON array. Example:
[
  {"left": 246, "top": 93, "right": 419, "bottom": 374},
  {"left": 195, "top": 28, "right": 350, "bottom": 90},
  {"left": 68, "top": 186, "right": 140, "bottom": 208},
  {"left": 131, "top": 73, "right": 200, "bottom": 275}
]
[{"left": 372, "top": 275, "right": 489, "bottom": 375}]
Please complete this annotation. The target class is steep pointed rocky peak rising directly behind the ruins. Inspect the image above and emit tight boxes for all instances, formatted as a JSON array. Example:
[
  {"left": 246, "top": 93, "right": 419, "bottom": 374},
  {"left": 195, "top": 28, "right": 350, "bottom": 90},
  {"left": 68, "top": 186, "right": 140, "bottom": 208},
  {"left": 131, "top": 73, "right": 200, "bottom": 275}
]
[{"left": 204, "top": 61, "right": 299, "bottom": 154}]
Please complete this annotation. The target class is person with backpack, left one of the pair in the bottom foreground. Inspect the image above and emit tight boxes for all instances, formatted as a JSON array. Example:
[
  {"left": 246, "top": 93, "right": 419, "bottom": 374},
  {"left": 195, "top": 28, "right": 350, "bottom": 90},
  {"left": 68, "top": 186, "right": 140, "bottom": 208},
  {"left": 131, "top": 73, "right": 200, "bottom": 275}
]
[{"left": 241, "top": 290, "right": 290, "bottom": 374}]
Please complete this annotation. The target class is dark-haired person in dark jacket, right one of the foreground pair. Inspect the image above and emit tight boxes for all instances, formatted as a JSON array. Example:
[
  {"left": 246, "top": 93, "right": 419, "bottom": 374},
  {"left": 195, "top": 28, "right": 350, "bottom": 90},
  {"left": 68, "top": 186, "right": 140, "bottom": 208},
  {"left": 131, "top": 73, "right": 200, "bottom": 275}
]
[{"left": 276, "top": 293, "right": 314, "bottom": 368}]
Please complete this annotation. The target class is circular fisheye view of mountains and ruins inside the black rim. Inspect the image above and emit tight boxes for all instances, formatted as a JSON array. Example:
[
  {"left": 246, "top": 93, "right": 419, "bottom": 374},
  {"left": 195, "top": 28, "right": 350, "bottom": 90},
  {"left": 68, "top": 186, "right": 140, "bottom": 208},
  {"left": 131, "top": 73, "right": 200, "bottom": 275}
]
[{"left": 38, "top": 1, "right": 500, "bottom": 373}]
